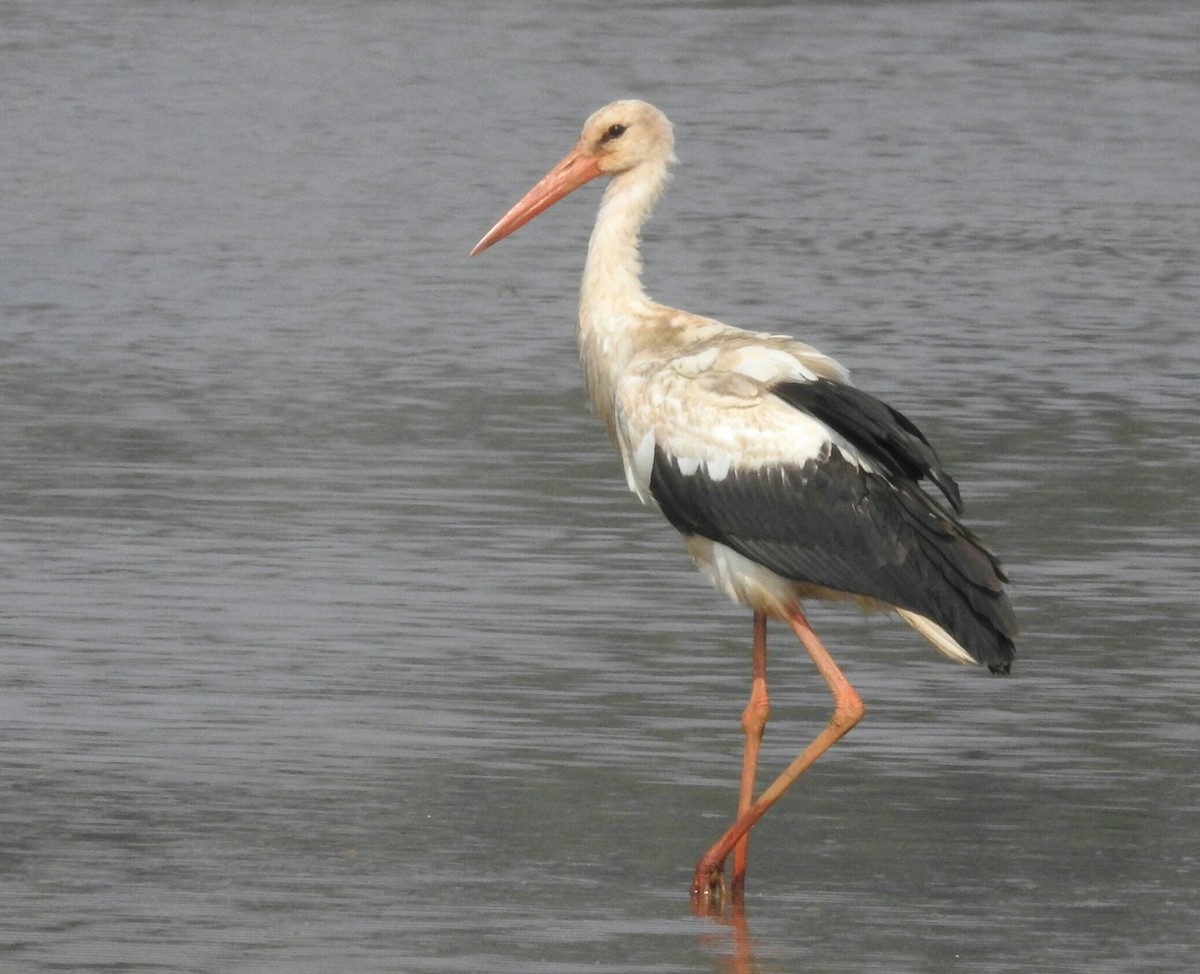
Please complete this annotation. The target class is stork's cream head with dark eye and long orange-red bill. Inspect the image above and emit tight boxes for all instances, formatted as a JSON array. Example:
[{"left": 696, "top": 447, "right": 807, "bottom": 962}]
[{"left": 470, "top": 100, "right": 674, "bottom": 257}]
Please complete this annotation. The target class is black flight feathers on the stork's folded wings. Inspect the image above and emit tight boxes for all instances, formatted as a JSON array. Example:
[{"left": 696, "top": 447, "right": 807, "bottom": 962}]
[{"left": 650, "top": 380, "right": 1016, "bottom": 672}]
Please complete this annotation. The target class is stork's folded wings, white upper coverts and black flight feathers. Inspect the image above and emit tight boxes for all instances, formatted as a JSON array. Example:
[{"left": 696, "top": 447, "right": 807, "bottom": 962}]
[{"left": 622, "top": 345, "right": 1016, "bottom": 671}]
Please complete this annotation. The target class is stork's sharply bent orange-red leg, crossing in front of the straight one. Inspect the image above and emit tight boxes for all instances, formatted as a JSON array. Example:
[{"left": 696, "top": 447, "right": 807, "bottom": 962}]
[{"left": 691, "top": 609, "right": 863, "bottom": 909}]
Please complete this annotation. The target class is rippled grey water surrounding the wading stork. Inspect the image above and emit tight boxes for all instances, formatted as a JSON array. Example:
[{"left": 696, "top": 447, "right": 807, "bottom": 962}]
[{"left": 0, "top": 0, "right": 1200, "bottom": 972}]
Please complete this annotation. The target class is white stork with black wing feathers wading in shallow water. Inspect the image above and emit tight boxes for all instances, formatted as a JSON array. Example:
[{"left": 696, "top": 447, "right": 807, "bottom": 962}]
[{"left": 472, "top": 101, "right": 1016, "bottom": 909}]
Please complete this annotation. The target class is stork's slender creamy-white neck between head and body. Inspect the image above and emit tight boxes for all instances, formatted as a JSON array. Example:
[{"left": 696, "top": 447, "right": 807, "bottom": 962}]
[{"left": 578, "top": 162, "right": 667, "bottom": 433}]
